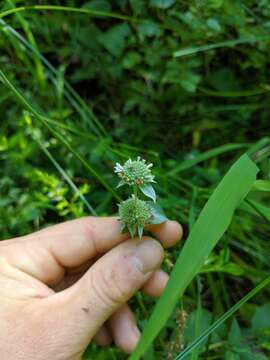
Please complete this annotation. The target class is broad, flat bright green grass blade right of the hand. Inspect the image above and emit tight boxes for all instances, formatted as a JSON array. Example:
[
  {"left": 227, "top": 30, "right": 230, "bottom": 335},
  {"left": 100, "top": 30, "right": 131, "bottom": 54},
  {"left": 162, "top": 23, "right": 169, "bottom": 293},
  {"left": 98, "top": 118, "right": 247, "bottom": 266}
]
[{"left": 130, "top": 155, "right": 258, "bottom": 360}]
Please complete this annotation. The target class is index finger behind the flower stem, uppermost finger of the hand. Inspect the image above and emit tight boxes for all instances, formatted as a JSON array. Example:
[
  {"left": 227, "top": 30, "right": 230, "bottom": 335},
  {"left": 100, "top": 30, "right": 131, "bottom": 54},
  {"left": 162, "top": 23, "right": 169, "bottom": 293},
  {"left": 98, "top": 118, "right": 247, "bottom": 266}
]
[{"left": 2, "top": 217, "right": 182, "bottom": 284}]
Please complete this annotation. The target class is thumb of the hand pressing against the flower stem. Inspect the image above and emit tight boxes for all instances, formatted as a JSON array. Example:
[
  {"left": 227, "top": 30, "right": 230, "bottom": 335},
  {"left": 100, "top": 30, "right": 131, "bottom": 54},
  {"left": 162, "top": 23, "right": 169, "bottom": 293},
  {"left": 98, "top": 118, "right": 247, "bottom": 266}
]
[{"left": 44, "top": 237, "right": 163, "bottom": 349}]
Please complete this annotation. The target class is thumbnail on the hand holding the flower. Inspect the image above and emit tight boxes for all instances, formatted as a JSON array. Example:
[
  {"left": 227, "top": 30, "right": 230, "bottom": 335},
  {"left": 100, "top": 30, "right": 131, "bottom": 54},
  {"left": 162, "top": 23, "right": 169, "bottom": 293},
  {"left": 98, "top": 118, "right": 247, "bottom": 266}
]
[{"left": 132, "top": 240, "right": 164, "bottom": 274}]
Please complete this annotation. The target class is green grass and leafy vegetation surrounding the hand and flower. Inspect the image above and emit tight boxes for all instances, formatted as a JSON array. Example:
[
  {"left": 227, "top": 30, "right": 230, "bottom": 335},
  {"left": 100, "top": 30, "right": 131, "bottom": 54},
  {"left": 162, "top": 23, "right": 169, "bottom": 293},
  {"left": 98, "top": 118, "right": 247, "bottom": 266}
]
[{"left": 0, "top": 0, "right": 270, "bottom": 360}]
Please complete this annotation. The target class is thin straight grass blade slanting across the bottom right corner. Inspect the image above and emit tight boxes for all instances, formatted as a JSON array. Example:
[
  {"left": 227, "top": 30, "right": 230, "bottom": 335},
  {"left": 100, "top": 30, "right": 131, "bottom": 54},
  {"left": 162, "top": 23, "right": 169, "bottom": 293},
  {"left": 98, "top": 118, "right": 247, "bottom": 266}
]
[{"left": 174, "top": 276, "right": 270, "bottom": 360}]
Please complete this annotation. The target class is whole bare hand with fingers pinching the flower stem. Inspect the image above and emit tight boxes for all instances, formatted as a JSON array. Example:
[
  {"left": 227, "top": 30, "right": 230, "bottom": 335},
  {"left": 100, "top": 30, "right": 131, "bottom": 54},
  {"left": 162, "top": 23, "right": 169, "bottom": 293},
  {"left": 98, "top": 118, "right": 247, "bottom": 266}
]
[{"left": 0, "top": 217, "right": 182, "bottom": 360}]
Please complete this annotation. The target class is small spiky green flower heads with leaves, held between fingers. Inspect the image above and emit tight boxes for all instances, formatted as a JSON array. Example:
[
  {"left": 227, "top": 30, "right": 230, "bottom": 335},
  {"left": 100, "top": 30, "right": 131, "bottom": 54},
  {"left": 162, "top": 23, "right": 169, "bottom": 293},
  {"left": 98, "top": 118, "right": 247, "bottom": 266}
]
[{"left": 114, "top": 156, "right": 167, "bottom": 238}]
